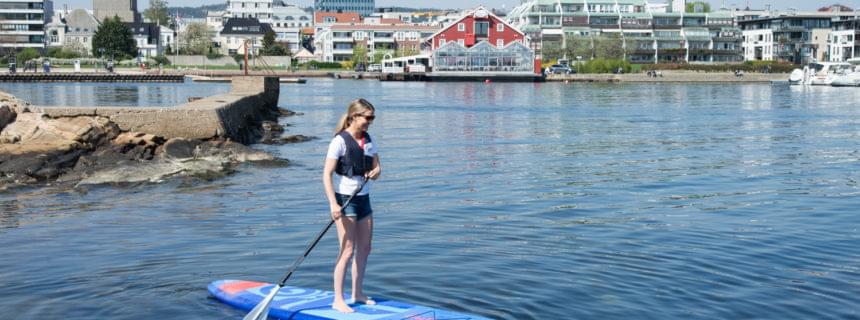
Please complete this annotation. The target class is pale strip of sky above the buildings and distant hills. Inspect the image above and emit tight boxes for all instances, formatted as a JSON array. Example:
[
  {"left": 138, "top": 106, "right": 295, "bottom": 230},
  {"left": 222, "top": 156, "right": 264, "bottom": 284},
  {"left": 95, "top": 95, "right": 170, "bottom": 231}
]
[{"left": 54, "top": 0, "right": 860, "bottom": 11}]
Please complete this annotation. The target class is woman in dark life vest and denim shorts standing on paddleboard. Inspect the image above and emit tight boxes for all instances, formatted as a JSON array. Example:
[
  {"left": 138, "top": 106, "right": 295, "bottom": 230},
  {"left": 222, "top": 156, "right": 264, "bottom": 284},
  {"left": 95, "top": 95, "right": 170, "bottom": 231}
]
[{"left": 323, "top": 99, "right": 380, "bottom": 313}]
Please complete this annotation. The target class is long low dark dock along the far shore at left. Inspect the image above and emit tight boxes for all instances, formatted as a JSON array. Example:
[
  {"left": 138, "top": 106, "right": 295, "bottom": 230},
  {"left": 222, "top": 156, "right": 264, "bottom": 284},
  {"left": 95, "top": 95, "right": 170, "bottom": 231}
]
[{"left": 0, "top": 73, "right": 185, "bottom": 83}]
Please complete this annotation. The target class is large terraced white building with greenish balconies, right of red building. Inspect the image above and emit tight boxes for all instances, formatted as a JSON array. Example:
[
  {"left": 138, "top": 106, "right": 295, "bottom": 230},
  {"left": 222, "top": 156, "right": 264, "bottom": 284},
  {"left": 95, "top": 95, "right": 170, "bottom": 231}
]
[{"left": 507, "top": 0, "right": 743, "bottom": 63}]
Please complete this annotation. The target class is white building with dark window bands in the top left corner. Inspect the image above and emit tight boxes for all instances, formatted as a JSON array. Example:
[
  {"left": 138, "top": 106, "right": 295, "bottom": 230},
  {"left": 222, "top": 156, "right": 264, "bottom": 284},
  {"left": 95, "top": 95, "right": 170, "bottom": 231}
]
[{"left": 0, "top": 0, "right": 48, "bottom": 49}]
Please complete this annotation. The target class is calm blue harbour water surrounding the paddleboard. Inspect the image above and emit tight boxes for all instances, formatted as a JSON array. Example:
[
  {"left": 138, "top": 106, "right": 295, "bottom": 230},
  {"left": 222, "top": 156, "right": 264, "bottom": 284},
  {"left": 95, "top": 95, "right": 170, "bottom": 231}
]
[{"left": 0, "top": 79, "right": 860, "bottom": 319}]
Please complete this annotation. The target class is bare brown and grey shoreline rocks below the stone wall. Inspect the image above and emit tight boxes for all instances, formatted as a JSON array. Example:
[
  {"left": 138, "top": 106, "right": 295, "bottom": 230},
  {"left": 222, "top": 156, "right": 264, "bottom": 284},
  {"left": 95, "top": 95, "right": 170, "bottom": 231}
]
[{"left": 0, "top": 79, "right": 312, "bottom": 191}]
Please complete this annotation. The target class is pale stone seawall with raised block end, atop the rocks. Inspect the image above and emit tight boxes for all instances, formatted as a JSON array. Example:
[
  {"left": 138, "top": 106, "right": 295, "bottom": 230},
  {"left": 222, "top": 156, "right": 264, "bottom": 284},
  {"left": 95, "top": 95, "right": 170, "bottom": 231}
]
[{"left": 30, "top": 77, "right": 280, "bottom": 144}]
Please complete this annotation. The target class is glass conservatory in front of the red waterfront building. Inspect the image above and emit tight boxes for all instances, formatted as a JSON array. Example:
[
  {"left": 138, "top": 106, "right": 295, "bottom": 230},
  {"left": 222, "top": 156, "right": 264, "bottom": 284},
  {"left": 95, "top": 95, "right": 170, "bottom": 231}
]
[{"left": 433, "top": 41, "right": 535, "bottom": 72}]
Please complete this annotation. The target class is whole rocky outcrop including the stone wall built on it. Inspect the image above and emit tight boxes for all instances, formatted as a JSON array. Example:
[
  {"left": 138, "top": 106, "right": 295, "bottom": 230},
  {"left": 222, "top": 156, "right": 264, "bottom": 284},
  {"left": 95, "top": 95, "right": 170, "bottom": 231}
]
[{"left": 0, "top": 77, "right": 291, "bottom": 188}]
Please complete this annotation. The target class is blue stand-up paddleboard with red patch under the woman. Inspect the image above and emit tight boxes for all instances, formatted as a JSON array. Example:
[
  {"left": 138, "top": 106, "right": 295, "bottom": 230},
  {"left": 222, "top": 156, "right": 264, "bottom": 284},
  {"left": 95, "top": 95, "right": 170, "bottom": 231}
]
[{"left": 209, "top": 280, "right": 489, "bottom": 320}]
